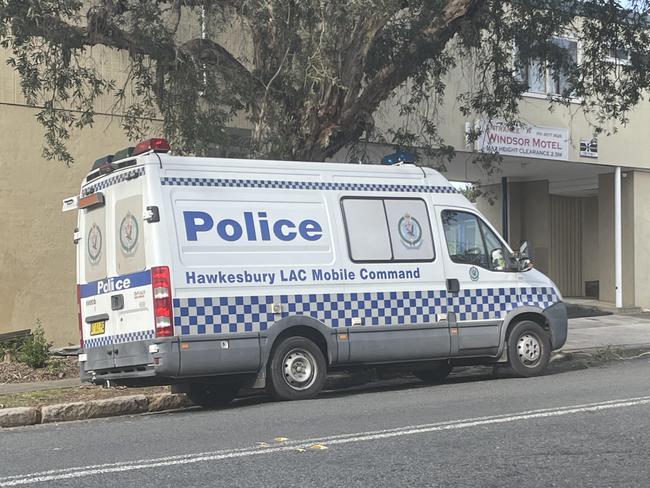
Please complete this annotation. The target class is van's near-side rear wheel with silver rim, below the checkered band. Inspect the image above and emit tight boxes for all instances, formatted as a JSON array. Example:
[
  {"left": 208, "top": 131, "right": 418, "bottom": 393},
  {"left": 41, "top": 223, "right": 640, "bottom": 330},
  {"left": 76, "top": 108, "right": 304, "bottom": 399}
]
[{"left": 267, "top": 336, "right": 327, "bottom": 400}]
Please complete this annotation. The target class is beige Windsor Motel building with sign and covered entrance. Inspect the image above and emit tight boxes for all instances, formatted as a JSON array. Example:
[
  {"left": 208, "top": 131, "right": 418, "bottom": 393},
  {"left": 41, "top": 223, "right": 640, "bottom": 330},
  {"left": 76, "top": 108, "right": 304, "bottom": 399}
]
[{"left": 371, "top": 60, "right": 650, "bottom": 311}]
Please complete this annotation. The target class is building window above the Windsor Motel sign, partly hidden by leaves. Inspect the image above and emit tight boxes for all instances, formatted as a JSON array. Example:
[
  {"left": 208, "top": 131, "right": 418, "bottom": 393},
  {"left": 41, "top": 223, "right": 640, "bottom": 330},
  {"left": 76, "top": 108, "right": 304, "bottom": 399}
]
[{"left": 519, "top": 38, "right": 578, "bottom": 96}]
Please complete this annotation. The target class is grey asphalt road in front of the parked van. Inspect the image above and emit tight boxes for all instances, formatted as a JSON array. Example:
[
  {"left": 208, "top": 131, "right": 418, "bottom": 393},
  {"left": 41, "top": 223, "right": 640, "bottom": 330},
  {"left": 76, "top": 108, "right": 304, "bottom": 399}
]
[{"left": 0, "top": 359, "right": 650, "bottom": 488}]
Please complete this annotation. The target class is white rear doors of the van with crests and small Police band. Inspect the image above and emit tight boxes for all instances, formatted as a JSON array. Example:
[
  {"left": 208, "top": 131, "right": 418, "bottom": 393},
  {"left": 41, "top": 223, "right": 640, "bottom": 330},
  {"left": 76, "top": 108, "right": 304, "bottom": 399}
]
[{"left": 80, "top": 168, "right": 155, "bottom": 371}]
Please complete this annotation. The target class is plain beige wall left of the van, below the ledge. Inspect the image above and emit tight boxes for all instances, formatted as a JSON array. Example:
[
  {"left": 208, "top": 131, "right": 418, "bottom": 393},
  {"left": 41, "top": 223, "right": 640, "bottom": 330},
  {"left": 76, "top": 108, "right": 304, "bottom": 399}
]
[{"left": 0, "top": 104, "right": 134, "bottom": 345}]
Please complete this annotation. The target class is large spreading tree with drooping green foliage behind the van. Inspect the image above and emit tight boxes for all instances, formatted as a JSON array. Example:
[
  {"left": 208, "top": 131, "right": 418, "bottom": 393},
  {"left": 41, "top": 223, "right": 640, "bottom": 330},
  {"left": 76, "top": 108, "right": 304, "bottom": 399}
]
[{"left": 0, "top": 0, "right": 650, "bottom": 163}]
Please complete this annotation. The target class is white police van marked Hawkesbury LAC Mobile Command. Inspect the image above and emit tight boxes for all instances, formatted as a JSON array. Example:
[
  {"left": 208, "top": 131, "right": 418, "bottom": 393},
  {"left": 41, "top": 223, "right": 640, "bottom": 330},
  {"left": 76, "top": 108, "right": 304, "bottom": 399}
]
[{"left": 63, "top": 139, "right": 567, "bottom": 406}]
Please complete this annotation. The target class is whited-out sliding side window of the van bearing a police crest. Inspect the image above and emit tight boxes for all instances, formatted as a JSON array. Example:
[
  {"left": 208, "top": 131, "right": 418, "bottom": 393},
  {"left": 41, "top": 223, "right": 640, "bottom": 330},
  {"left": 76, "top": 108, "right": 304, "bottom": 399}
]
[{"left": 341, "top": 197, "right": 435, "bottom": 262}]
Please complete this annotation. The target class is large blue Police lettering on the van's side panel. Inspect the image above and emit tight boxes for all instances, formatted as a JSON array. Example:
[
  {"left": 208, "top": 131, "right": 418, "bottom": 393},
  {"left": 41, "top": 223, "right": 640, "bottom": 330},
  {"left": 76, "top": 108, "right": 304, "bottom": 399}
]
[{"left": 183, "top": 212, "right": 323, "bottom": 242}]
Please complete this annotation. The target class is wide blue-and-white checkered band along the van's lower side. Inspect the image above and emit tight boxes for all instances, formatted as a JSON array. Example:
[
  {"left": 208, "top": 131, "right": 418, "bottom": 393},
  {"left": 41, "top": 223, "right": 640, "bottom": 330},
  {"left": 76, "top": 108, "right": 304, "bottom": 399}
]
[{"left": 174, "top": 288, "right": 559, "bottom": 335}]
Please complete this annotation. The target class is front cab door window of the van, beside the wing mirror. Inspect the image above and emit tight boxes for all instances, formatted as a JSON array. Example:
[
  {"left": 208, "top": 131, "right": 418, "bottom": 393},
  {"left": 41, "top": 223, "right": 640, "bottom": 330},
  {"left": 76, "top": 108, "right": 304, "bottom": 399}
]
[{"left": 442, "top": 210, "right": 509, "bottom": 271}]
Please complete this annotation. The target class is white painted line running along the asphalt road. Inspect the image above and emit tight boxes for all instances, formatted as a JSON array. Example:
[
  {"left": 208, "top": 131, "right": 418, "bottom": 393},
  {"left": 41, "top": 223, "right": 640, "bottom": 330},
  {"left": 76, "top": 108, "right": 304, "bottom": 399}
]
[{"left": 0, "top": 396, "right": 650, "bottom": 487}]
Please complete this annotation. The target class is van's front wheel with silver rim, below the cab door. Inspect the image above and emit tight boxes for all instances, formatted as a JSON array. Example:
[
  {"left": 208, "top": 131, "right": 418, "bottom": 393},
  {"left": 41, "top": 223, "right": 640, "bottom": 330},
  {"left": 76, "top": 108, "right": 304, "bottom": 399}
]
[{"left": 508, "top": 320, "right": 551, "bottom": 377}]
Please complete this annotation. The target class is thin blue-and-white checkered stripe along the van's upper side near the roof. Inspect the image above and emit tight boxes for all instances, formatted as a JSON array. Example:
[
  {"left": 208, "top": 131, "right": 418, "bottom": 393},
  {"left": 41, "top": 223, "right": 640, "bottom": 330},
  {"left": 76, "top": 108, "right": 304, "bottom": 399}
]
[{"left": 160, "top": 177, "right": 458, "bottom": 193}]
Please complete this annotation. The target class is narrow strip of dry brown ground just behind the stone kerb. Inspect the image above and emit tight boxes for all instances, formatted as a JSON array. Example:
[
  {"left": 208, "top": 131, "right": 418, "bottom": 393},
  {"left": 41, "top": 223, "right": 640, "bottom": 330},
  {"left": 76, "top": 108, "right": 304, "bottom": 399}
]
[{"left": 0, "top": 385, "right": 170, "bottom": 408}]
